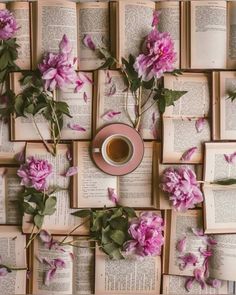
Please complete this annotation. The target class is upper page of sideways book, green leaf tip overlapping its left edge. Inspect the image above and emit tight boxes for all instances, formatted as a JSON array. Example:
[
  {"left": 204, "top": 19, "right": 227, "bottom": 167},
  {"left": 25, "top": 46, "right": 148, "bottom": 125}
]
[{"left": 164, "top": 73, "right": 210, "bottom": 117}]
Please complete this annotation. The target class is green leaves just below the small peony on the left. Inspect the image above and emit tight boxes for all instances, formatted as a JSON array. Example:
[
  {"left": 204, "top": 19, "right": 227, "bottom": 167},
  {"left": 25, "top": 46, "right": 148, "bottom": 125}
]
[{"left": 21, "top": 188, "right": 57, "bottom": 229}]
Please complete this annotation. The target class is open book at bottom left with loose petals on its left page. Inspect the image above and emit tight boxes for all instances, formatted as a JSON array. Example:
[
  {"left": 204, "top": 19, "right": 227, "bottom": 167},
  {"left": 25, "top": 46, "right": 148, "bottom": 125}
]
[{"left": 29, "top": 236, "right": 94, "bottom": 295}]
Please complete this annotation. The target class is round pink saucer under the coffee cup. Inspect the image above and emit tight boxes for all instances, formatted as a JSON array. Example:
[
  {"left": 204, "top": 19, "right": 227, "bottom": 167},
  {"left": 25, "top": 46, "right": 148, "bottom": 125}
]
[{"left": 91, "top": 123, "right": 144, "bottom": 176}]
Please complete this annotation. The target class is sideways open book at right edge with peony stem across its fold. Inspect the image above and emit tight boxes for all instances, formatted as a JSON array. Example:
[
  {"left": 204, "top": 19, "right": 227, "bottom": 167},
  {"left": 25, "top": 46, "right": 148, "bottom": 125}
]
[{"left": 203, "top": 142, "right": 236, "bottom": 233}]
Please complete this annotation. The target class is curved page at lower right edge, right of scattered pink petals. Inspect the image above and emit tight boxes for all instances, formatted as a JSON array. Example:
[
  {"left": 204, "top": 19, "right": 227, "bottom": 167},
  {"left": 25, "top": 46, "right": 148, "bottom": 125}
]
[{"left": 209, "top": 235, "right": 236, "bottom": 281}]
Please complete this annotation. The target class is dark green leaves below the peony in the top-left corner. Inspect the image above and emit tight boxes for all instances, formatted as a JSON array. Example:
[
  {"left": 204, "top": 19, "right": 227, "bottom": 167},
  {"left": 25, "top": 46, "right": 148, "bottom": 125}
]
[{"left": 0, "top": 38, "right": 19, "bottom": 83}]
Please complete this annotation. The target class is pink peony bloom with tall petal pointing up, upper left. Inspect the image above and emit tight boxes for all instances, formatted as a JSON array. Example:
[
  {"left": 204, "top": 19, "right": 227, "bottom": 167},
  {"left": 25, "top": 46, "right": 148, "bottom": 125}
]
[{"left": 38, "top": 35, "right": 77, "bottom": 91}]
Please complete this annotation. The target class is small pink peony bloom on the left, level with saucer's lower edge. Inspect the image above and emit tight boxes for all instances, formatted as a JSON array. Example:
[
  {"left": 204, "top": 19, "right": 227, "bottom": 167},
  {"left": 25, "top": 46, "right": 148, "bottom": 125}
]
[{"left": 17, "top": 157, "right": 52, "bottom": 191}]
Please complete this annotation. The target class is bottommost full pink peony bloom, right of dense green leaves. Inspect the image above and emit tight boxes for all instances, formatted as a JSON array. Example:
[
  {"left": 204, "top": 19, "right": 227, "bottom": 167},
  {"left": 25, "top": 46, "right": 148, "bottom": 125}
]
[{"left": 124, "top": 212, "right": 164, "bottom": 256}]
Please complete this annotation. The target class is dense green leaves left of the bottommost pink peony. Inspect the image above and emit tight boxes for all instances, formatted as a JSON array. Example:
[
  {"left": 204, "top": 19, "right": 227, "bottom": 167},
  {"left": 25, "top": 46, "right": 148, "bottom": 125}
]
[{"left": 72, "top": 206, "right": 136, "bottom": 259}]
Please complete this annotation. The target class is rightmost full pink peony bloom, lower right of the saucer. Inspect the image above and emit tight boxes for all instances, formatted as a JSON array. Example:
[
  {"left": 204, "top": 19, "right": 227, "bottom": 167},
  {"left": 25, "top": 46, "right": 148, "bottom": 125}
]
[{"left": 161, "top": 167, "right": 203, "bottom": 211}]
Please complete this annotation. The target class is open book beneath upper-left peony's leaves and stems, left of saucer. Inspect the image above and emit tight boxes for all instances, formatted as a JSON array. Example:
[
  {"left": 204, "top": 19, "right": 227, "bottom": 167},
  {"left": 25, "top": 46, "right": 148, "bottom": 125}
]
[{"left": 10, "top": 72, "right": 93, "bottom": 141}]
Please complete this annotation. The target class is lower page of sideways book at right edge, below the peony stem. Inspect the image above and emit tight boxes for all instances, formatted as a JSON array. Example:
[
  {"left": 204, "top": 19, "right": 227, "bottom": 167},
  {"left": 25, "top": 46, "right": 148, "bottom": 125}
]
[{"left": 203, "top": 185, "right": 236, "bottom": 233}]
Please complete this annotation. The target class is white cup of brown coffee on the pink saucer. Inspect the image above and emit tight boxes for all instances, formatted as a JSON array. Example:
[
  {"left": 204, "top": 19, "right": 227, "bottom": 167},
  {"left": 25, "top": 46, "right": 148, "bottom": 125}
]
[{"left": 93, "top": 134, "right": 134, "bottom": 167}]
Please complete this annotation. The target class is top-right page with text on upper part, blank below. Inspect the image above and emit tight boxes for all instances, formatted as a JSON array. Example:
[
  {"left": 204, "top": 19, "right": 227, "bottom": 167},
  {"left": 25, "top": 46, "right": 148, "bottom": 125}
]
[{"left": 190, "top": 1, "right": 227, "bottom": 69}]
